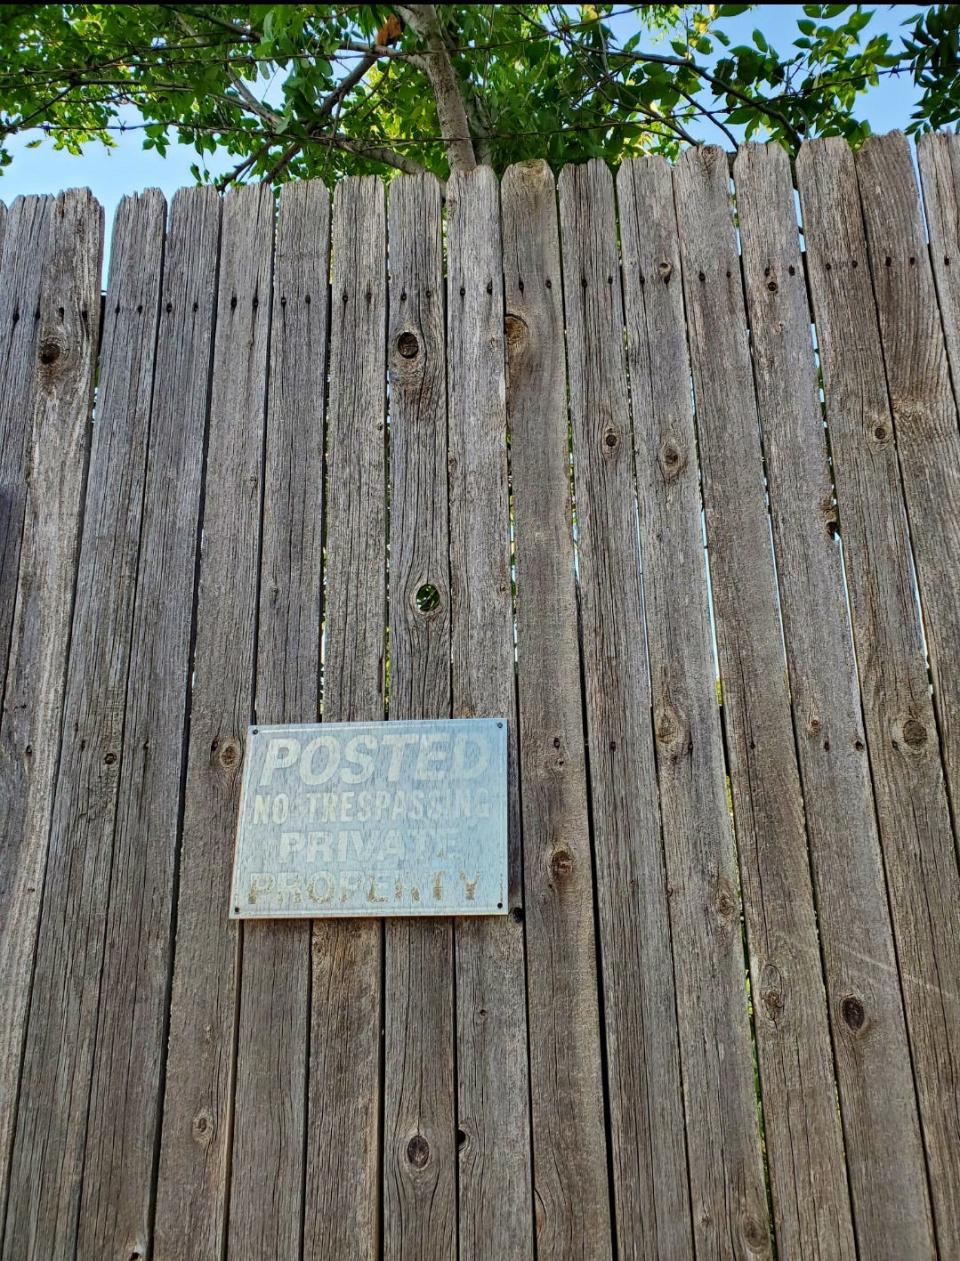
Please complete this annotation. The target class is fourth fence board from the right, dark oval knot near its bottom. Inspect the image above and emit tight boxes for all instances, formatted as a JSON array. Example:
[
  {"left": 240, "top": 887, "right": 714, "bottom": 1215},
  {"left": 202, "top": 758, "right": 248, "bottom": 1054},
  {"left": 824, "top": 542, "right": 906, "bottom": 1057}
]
[{"left": 724, "top": 145, "right": 931, "bottom": 1257}]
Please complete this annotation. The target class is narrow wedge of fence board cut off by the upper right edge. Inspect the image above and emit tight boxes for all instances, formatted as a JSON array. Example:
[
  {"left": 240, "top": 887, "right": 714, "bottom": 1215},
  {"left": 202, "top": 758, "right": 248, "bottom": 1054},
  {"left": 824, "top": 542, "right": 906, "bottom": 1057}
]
[{"left": 917, "top": 131, "right": 960, "bottom": 421}]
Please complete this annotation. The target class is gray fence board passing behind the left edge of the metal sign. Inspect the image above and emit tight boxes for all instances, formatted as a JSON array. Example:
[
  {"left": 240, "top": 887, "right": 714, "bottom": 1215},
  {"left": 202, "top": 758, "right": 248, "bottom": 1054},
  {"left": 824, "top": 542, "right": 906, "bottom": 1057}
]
[{"left": 227, "top": 180, "right": 329, "bottom": 1261}]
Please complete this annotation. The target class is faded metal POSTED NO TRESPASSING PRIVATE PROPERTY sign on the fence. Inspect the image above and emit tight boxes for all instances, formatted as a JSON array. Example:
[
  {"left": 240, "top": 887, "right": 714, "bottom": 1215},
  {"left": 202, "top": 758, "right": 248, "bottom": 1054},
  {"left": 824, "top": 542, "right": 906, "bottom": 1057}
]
[{"left": 230, "top": 719, "right": 507, "bottom": 919}]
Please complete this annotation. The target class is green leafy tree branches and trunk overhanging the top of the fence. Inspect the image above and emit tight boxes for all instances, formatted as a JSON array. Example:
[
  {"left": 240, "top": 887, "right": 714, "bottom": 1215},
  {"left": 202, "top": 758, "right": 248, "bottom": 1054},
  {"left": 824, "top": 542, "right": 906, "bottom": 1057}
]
[{"left": 0, "top": 4, "right": 960, "bottom": 183}]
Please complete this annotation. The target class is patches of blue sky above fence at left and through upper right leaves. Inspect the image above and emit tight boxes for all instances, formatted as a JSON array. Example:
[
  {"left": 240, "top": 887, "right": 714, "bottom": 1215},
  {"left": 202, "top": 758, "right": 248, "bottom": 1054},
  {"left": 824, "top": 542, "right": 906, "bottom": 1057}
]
[{"left": 0, "top": 5, "right": 921, "bottom": 237}]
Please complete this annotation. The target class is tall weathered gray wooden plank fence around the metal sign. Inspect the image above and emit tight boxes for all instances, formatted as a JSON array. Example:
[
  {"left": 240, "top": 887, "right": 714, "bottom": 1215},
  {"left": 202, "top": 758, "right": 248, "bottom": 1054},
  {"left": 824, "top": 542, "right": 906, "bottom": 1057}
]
[{"left": 0, "top": 135, "right": 960, "bottom": 1261}]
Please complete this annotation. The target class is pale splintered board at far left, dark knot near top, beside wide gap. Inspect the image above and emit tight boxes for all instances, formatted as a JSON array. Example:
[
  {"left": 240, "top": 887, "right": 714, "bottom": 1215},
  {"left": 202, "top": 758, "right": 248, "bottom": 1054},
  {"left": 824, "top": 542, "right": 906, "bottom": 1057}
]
[{"left": 0, "top": 190, "right": 103, "bottom": 1240}]
